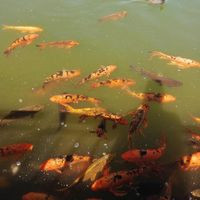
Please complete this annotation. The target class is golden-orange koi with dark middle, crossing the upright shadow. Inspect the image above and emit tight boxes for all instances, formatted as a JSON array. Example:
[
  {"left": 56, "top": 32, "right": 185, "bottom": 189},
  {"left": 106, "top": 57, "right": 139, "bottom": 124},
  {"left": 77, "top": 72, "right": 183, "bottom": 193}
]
[{"left": 126, "top": 89, "right": 176, "bottom": 103}]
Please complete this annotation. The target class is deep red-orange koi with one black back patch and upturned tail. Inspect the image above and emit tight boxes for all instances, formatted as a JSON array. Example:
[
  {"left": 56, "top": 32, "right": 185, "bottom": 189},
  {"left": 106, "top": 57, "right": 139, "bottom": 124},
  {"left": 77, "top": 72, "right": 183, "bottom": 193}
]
[{"left": 121, "top": 137, "right": 166, "bottom": 163}]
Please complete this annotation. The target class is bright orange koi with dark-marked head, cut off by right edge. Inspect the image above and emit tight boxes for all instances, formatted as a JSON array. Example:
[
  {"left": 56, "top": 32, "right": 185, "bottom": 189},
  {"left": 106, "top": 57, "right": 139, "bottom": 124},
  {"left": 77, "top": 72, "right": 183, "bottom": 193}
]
[{"left": 180, "top": 152, "right": 200, "bottom": 171}]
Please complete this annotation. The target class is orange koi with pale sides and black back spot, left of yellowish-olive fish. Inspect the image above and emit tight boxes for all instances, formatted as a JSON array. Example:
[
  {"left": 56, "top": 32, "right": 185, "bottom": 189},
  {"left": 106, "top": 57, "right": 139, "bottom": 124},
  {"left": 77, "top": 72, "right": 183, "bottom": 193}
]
[{"left": 40, "top": 154, "right": 91, "bottom": 173}]
